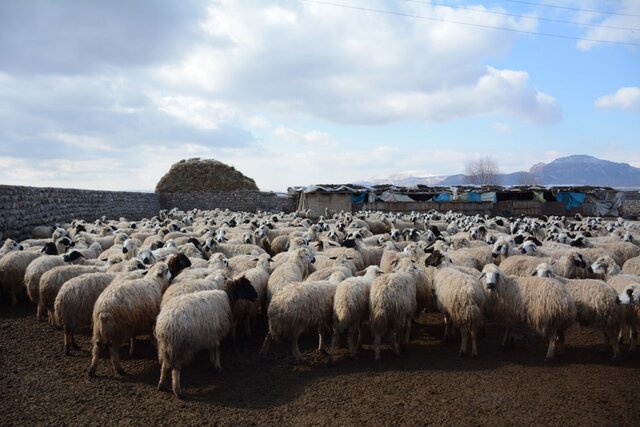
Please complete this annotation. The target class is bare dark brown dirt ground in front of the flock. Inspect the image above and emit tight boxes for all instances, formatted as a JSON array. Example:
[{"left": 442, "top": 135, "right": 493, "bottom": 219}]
[{"left": 0, "top": 302, "right": 640, "bottom": 426}]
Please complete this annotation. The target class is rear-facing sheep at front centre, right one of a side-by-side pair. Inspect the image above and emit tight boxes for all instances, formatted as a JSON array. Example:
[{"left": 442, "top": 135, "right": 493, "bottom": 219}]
[{"left": 369, "top": 258, "right": 420, "bottom": 360}]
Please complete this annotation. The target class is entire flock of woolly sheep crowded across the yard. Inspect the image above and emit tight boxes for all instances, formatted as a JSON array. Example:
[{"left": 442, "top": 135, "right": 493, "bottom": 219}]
[{"left": 0, "top": 209, "right": 640, "bottom": 397}]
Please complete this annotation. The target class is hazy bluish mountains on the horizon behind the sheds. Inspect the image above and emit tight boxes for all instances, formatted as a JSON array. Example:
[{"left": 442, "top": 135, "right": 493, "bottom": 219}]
[{"left": 357, "top": 154, "right": 640, "bottom": 187}]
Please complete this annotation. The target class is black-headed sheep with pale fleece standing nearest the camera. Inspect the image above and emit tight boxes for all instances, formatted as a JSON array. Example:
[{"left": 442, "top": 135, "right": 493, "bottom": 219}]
[{"left": 155, "top": 280, "right": 257, "bottom": 398}]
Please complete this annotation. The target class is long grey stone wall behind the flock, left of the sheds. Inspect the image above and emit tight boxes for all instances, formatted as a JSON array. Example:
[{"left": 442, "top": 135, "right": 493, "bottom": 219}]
[{"left": 0, "top": 185, "right": 295, "bottom": 238}]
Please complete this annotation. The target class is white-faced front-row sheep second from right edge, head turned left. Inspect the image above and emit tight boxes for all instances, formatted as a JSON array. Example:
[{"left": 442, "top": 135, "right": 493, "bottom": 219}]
[{"left": 536, "top": 263, "right": 622, "bottom": 359}]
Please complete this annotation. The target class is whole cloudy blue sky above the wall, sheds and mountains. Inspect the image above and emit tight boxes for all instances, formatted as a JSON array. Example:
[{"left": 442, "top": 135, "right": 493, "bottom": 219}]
[{"left": 0, "top": 0, "right": 640, "bottom": 191}]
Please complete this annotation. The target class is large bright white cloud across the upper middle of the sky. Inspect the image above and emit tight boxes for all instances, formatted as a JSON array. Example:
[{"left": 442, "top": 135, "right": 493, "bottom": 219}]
[{"left": 156, "top": 1, "right": 560, "bottom": 124}]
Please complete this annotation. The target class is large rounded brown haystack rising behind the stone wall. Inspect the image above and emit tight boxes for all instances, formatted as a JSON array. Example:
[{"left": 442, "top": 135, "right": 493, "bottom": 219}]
[{"left": 156, "top": 157, "right": 258, "bottom": 193}]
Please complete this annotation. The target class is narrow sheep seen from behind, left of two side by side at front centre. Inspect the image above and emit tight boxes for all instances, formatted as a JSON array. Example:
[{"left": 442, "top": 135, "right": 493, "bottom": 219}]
[{"left": 331, "top": 265, "right": 382, "bottom": 359}]
